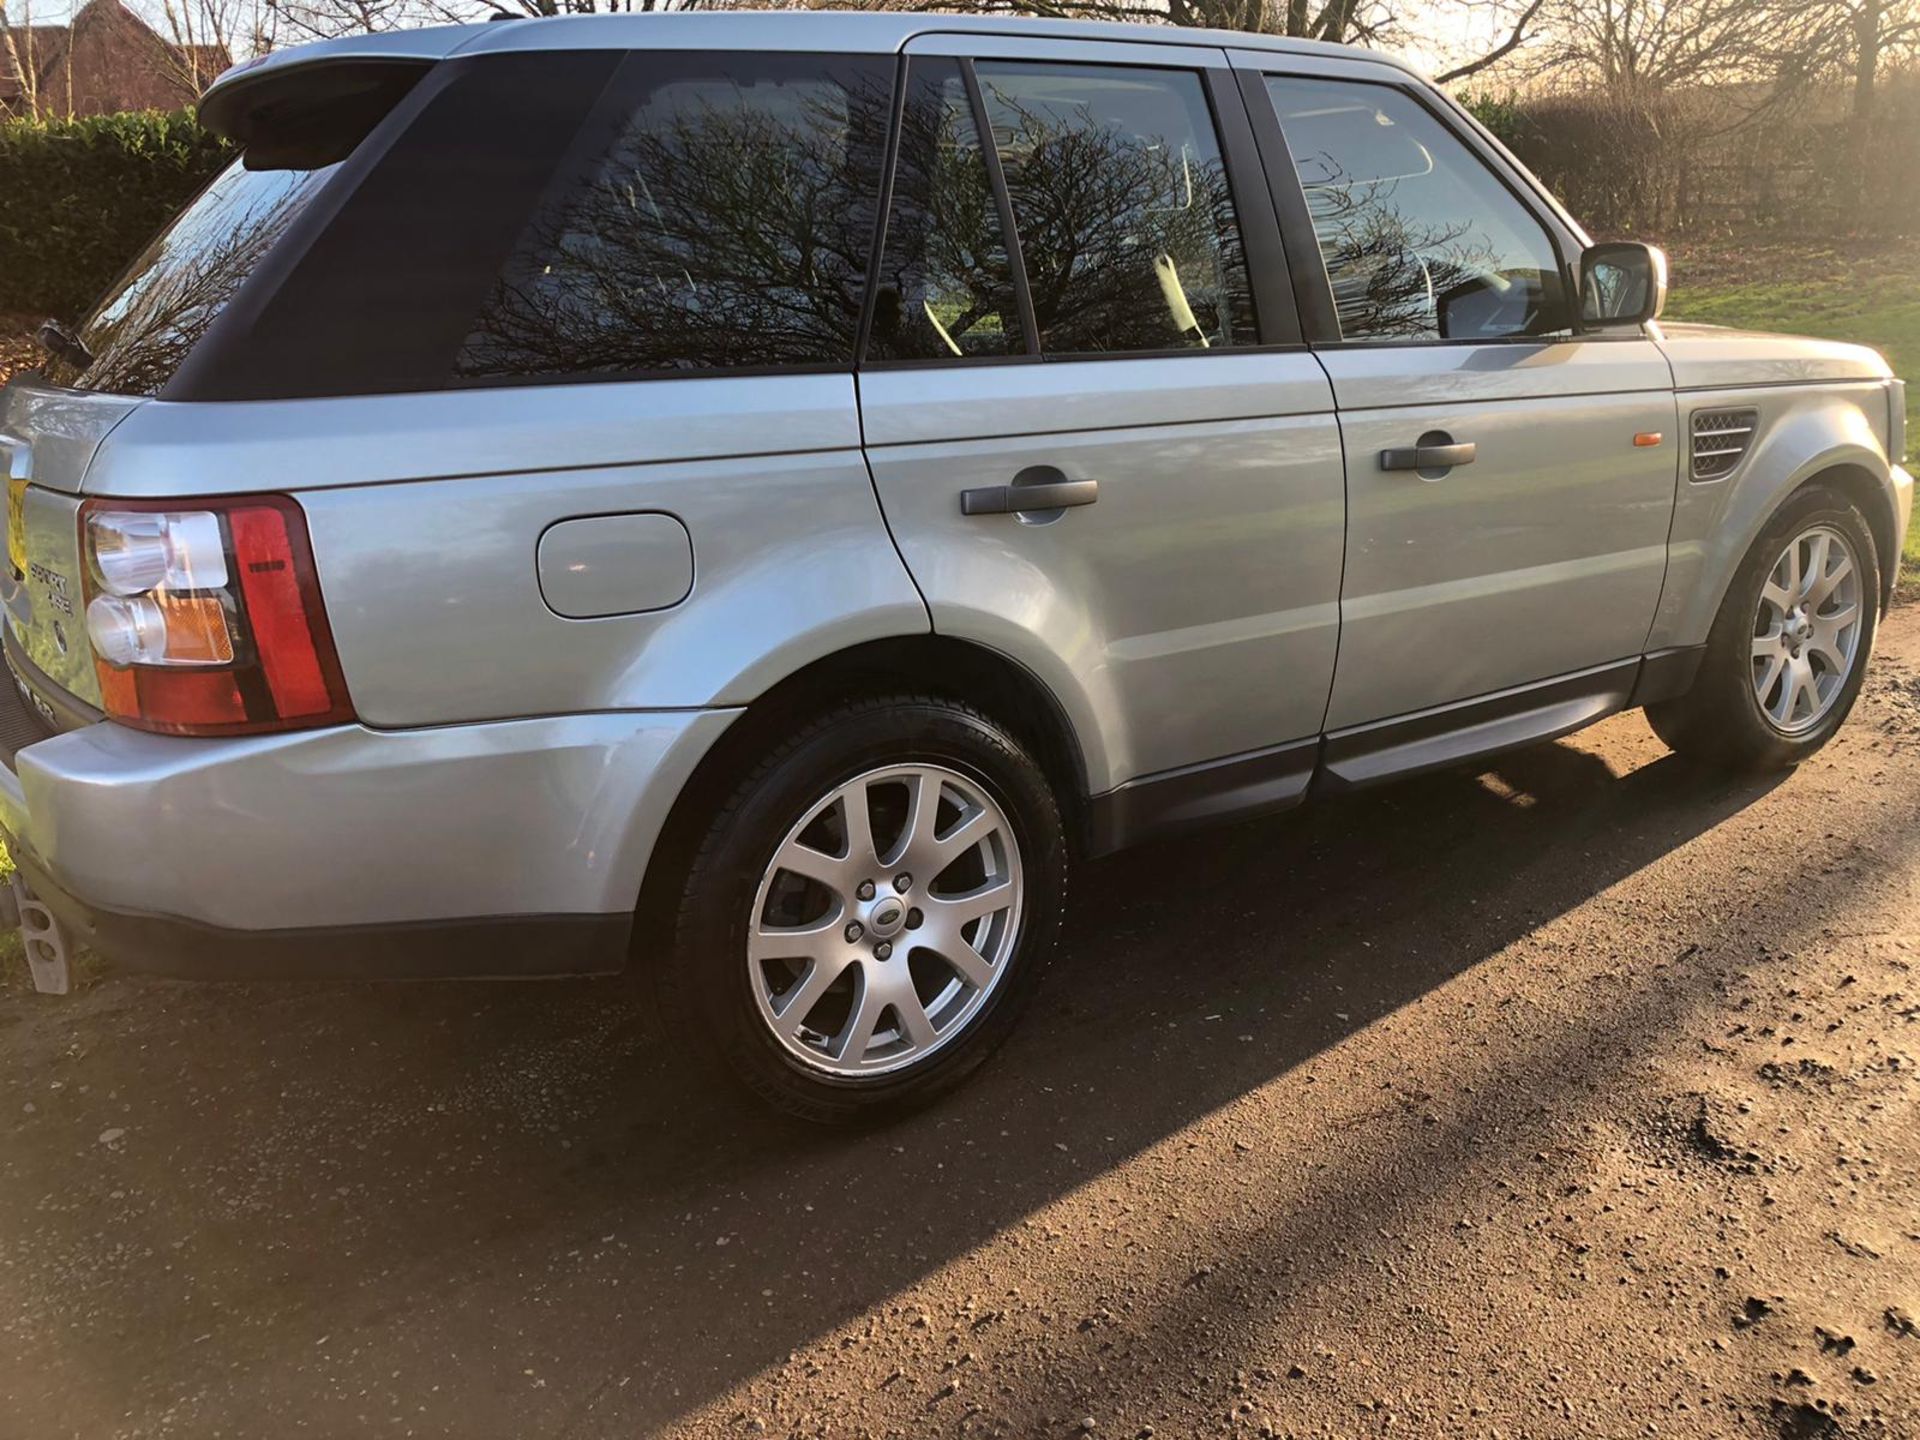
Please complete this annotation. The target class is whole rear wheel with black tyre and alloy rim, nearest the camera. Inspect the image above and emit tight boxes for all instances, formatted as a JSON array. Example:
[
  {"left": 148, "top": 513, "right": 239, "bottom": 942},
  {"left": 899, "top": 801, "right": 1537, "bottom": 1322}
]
[{"left": 659, "top": 695, "right": 1068, "bottom": 1123}]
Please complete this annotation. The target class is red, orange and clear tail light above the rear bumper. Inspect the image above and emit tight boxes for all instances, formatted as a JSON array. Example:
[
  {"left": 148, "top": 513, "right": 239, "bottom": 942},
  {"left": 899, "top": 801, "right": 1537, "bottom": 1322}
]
[{"left": 81, "top": 495, "right": 353, "bottom": 735}]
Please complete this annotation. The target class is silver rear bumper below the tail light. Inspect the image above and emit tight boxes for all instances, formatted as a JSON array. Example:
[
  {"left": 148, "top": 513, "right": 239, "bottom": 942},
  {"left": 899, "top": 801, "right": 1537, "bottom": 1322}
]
[{"left": 0, "top": 710, "right": 737, "bottom": 977}]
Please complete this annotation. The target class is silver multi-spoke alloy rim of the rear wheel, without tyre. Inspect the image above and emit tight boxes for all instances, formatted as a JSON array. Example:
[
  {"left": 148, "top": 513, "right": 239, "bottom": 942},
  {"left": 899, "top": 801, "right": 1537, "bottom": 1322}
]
[{"left": 747, "top": 764, "right": 1023, "bottom": 1075}]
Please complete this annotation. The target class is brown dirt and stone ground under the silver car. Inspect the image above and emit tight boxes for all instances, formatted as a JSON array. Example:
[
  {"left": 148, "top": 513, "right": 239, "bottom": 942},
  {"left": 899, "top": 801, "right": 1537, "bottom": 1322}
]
[{"left": 0, "top": 607, "right": 1920, "bottom": 1440}]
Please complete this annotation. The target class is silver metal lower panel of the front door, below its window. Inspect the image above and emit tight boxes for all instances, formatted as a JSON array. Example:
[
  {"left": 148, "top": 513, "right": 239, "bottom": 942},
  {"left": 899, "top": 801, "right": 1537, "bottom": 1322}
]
[{"left": 1321, "top": 340, "right": 1678, "bottom": 730}]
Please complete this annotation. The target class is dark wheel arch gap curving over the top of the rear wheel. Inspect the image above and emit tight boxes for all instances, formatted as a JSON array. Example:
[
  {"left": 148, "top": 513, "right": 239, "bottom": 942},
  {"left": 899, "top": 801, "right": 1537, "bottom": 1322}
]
[{"left": 634, "top": 634, "right": 1089, "bottom": 960}]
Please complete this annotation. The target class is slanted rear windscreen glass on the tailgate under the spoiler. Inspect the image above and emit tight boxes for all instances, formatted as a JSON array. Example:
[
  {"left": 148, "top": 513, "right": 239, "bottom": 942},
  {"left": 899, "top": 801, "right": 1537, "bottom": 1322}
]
[{"left": 46, "top": 161, "right": 338, "bottom": 396}]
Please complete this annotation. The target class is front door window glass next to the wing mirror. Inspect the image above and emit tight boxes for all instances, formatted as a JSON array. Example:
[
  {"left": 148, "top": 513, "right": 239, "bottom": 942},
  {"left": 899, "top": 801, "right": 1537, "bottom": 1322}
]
[{"left": 1267, "top": 77, "right": 1571, "bottom": 340}]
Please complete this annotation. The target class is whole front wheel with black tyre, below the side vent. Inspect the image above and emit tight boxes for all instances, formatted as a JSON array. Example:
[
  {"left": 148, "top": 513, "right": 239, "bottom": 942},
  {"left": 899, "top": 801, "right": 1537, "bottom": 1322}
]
[{"left": 1647, "top": 486, "right": 1880, "bottom": 772}]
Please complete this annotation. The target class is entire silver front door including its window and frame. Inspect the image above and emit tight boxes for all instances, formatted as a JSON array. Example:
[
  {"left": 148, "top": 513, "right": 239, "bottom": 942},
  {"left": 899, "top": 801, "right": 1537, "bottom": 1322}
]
[{"left": 1235, "top": 54, "right": 1680, "bottom": 730}]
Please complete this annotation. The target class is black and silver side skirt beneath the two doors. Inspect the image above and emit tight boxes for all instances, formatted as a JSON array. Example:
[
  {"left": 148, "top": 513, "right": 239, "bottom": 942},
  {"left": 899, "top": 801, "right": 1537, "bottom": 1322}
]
[{"left": 1089, "top": 645, "right": 1705, "bottom": 854}]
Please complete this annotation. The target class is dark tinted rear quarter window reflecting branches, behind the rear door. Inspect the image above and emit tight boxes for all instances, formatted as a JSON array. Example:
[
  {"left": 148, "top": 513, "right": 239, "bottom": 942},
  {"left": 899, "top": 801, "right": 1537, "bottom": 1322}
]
[{"left": 455, "top": 52, "right": 893, "bottom": 378}]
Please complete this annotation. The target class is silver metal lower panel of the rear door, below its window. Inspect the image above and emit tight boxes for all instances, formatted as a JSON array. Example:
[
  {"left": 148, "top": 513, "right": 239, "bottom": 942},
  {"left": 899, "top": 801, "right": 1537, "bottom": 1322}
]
[{"left": 860, "top": 353, "right": 1344, "bottom": 789}]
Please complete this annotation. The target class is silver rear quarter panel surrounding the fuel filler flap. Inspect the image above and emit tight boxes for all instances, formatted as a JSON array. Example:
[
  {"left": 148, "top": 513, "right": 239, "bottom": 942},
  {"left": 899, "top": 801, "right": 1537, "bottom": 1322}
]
[{"left": 88, "top": 374, "right": 927, "bottom": 728}]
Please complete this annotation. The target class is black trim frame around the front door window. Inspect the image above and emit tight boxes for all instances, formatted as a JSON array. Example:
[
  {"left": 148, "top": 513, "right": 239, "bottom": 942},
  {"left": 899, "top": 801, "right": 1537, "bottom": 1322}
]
[{"left": 1238, "top": 61, "right": 1589, "bottom": 349}]
